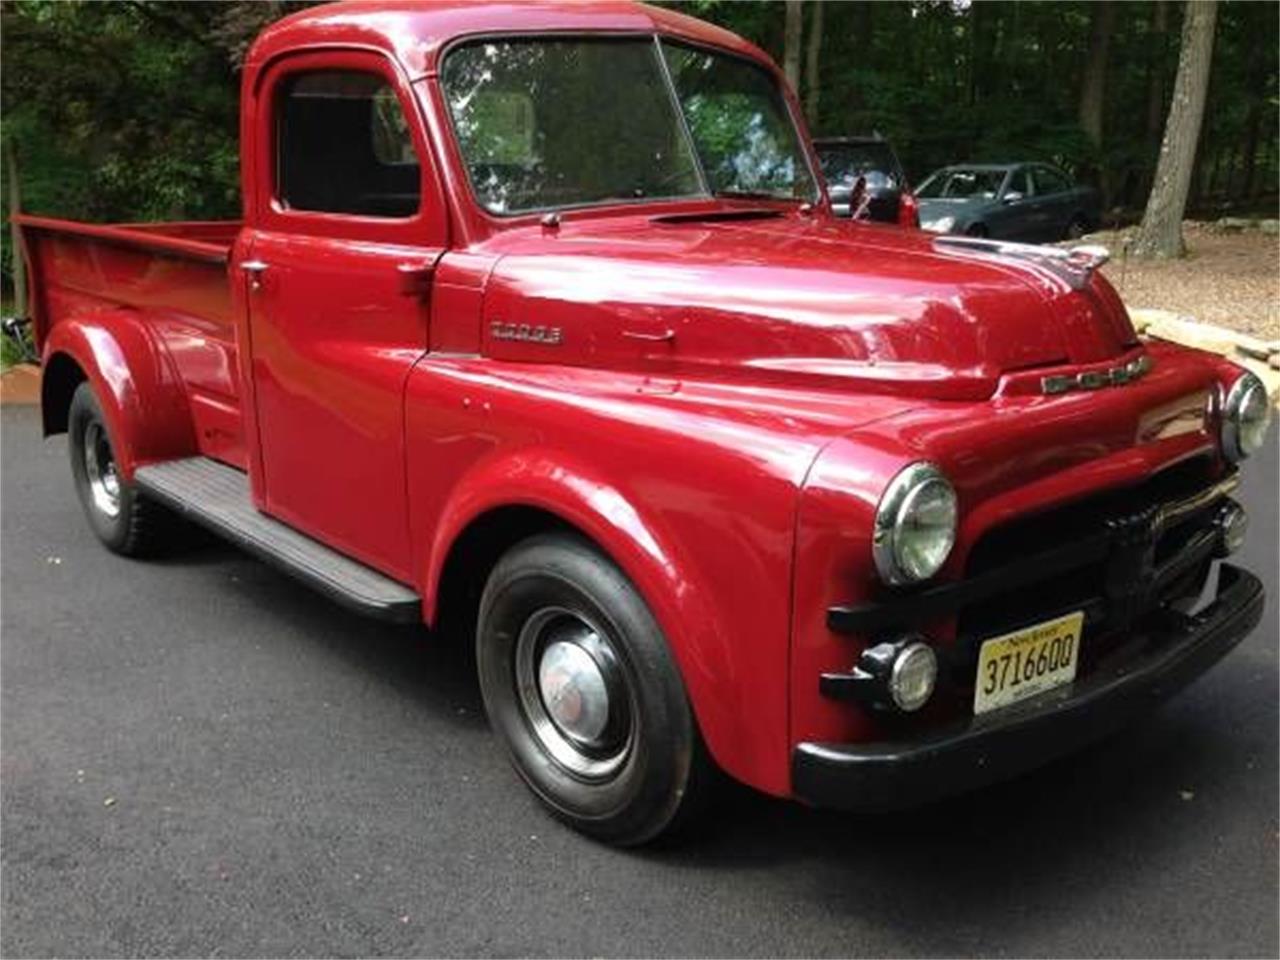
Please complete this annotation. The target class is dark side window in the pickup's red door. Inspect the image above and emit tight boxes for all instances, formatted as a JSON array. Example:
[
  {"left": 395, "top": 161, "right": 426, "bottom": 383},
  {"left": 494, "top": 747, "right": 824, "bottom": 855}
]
[{"left": 275, "top": 70, "right": 421, "bottom": 218}]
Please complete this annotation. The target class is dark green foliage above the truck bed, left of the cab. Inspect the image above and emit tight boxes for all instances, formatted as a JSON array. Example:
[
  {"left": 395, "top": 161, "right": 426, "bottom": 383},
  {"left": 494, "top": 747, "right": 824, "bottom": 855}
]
[{"left": 3, "top": 0, "right": 239, "bottom": 220}]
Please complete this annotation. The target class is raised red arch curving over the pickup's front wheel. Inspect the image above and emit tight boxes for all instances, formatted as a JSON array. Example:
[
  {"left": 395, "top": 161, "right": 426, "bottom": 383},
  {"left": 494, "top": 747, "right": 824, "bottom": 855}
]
[{"left": 424, "top": 448, "right": 747, "bottom": 792}]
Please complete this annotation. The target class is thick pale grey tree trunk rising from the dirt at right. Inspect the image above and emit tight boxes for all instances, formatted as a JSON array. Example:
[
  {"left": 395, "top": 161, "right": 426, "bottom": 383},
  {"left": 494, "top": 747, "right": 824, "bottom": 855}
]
[{"left": 1133, "top": 0, "right": 1217, "bottom": 257}]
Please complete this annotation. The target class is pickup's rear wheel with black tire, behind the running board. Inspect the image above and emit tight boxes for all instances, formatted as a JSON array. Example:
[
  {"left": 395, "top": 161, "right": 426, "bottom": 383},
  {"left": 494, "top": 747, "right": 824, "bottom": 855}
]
[{"left": 67, "top": 381, "right": 173, "bottom": 557}]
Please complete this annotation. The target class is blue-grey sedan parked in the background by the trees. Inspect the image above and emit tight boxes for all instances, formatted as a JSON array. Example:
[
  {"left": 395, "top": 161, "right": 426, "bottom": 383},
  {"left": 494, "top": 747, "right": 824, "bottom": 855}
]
[{"left": 915, "top": 164, "right": 1101, "bottom": 243}]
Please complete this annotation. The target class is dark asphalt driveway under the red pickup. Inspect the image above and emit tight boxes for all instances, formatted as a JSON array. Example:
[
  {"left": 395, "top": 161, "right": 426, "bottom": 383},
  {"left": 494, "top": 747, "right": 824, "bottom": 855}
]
[{"left": 0, "top": 408, "right": 1280, "bottom": 956}]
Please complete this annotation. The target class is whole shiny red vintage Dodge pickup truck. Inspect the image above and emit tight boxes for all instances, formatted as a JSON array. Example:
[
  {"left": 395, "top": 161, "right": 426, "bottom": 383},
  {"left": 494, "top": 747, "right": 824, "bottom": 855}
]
[{"left": 10, "top": 0, "right": 1270, "bottom": 844}]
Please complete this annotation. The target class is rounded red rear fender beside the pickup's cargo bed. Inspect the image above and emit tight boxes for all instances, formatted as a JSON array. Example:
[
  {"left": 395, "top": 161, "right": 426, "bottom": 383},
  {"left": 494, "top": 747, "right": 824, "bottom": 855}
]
[{"left": 41, "top": 308, "right": 196, "bottom": 479}]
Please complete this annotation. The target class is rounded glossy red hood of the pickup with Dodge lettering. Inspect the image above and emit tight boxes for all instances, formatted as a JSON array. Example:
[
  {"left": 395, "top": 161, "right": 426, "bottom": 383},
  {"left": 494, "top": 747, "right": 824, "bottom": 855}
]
[{"left": 484, "top": 211, "right": 1137, "bottom": 399}]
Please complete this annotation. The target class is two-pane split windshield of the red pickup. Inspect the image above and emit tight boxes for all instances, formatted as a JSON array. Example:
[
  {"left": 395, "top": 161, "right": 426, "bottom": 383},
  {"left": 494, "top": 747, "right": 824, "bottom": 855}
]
[{"left": 442, "top": 37, "right": 813, "bottom": 214}]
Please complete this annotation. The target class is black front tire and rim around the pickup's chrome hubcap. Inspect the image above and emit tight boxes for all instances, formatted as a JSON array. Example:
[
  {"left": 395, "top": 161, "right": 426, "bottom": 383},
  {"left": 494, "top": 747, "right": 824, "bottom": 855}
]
[{"left": 476, "top": 534, "right": 714, "bottom": 846}]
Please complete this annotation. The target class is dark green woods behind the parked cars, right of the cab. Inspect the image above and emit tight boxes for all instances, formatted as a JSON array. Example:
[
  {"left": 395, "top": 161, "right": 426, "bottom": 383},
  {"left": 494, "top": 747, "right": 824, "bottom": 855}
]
[{"left": 667, "top": 0, "right": 1277, "bottom": 216}]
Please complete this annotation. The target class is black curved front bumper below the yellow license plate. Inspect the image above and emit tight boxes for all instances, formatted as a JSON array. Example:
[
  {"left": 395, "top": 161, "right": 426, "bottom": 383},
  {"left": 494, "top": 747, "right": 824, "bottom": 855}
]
[{"left": 791, "top": 563, "right": 1265, "bottom": 809}]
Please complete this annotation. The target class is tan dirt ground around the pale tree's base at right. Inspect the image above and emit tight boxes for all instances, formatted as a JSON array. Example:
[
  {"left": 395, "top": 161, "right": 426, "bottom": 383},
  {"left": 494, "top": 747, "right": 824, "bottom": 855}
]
[{"left": 1088, "top": 223, "right": 1280, "bottom": 340}]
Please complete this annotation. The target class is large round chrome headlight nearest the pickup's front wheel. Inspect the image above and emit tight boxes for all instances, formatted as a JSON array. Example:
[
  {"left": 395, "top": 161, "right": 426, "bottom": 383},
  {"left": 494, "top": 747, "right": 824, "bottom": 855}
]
[{"left": 872, "top": 461, "right": 956, "bottom": 584}]
